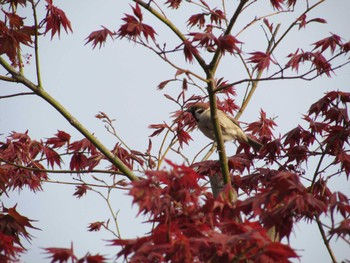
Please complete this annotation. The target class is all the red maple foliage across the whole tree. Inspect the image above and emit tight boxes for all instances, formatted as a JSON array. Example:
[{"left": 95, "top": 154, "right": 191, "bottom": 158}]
[{"left": 0, "top": 0, "right": 350, "bottom": 263}]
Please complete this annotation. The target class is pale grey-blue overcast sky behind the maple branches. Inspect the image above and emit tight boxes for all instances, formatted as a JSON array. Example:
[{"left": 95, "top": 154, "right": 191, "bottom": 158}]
[{"left": 0, "top": 0, "right": 350, "bottom": 263}]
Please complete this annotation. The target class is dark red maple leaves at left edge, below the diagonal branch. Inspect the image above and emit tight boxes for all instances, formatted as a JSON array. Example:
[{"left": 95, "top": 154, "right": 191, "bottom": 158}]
[{"left": 0, "top": 127, "right": 152, "bottom": 197}]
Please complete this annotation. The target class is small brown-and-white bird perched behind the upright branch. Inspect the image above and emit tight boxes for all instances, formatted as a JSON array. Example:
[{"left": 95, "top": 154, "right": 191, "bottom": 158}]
[{"left": 186, "top": 103, "right": 263, "bottom": 151}]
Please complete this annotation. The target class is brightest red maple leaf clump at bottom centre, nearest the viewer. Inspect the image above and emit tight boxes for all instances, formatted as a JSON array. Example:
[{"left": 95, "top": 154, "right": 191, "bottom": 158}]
[{"left": 111, "top": 163, "right": 297, "bottom": 262}]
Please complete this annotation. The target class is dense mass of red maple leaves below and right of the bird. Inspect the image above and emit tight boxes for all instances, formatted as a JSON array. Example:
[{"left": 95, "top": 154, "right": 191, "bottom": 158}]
[{"left": 112, "top": 91, "right": 350, "bottom": 262}]
